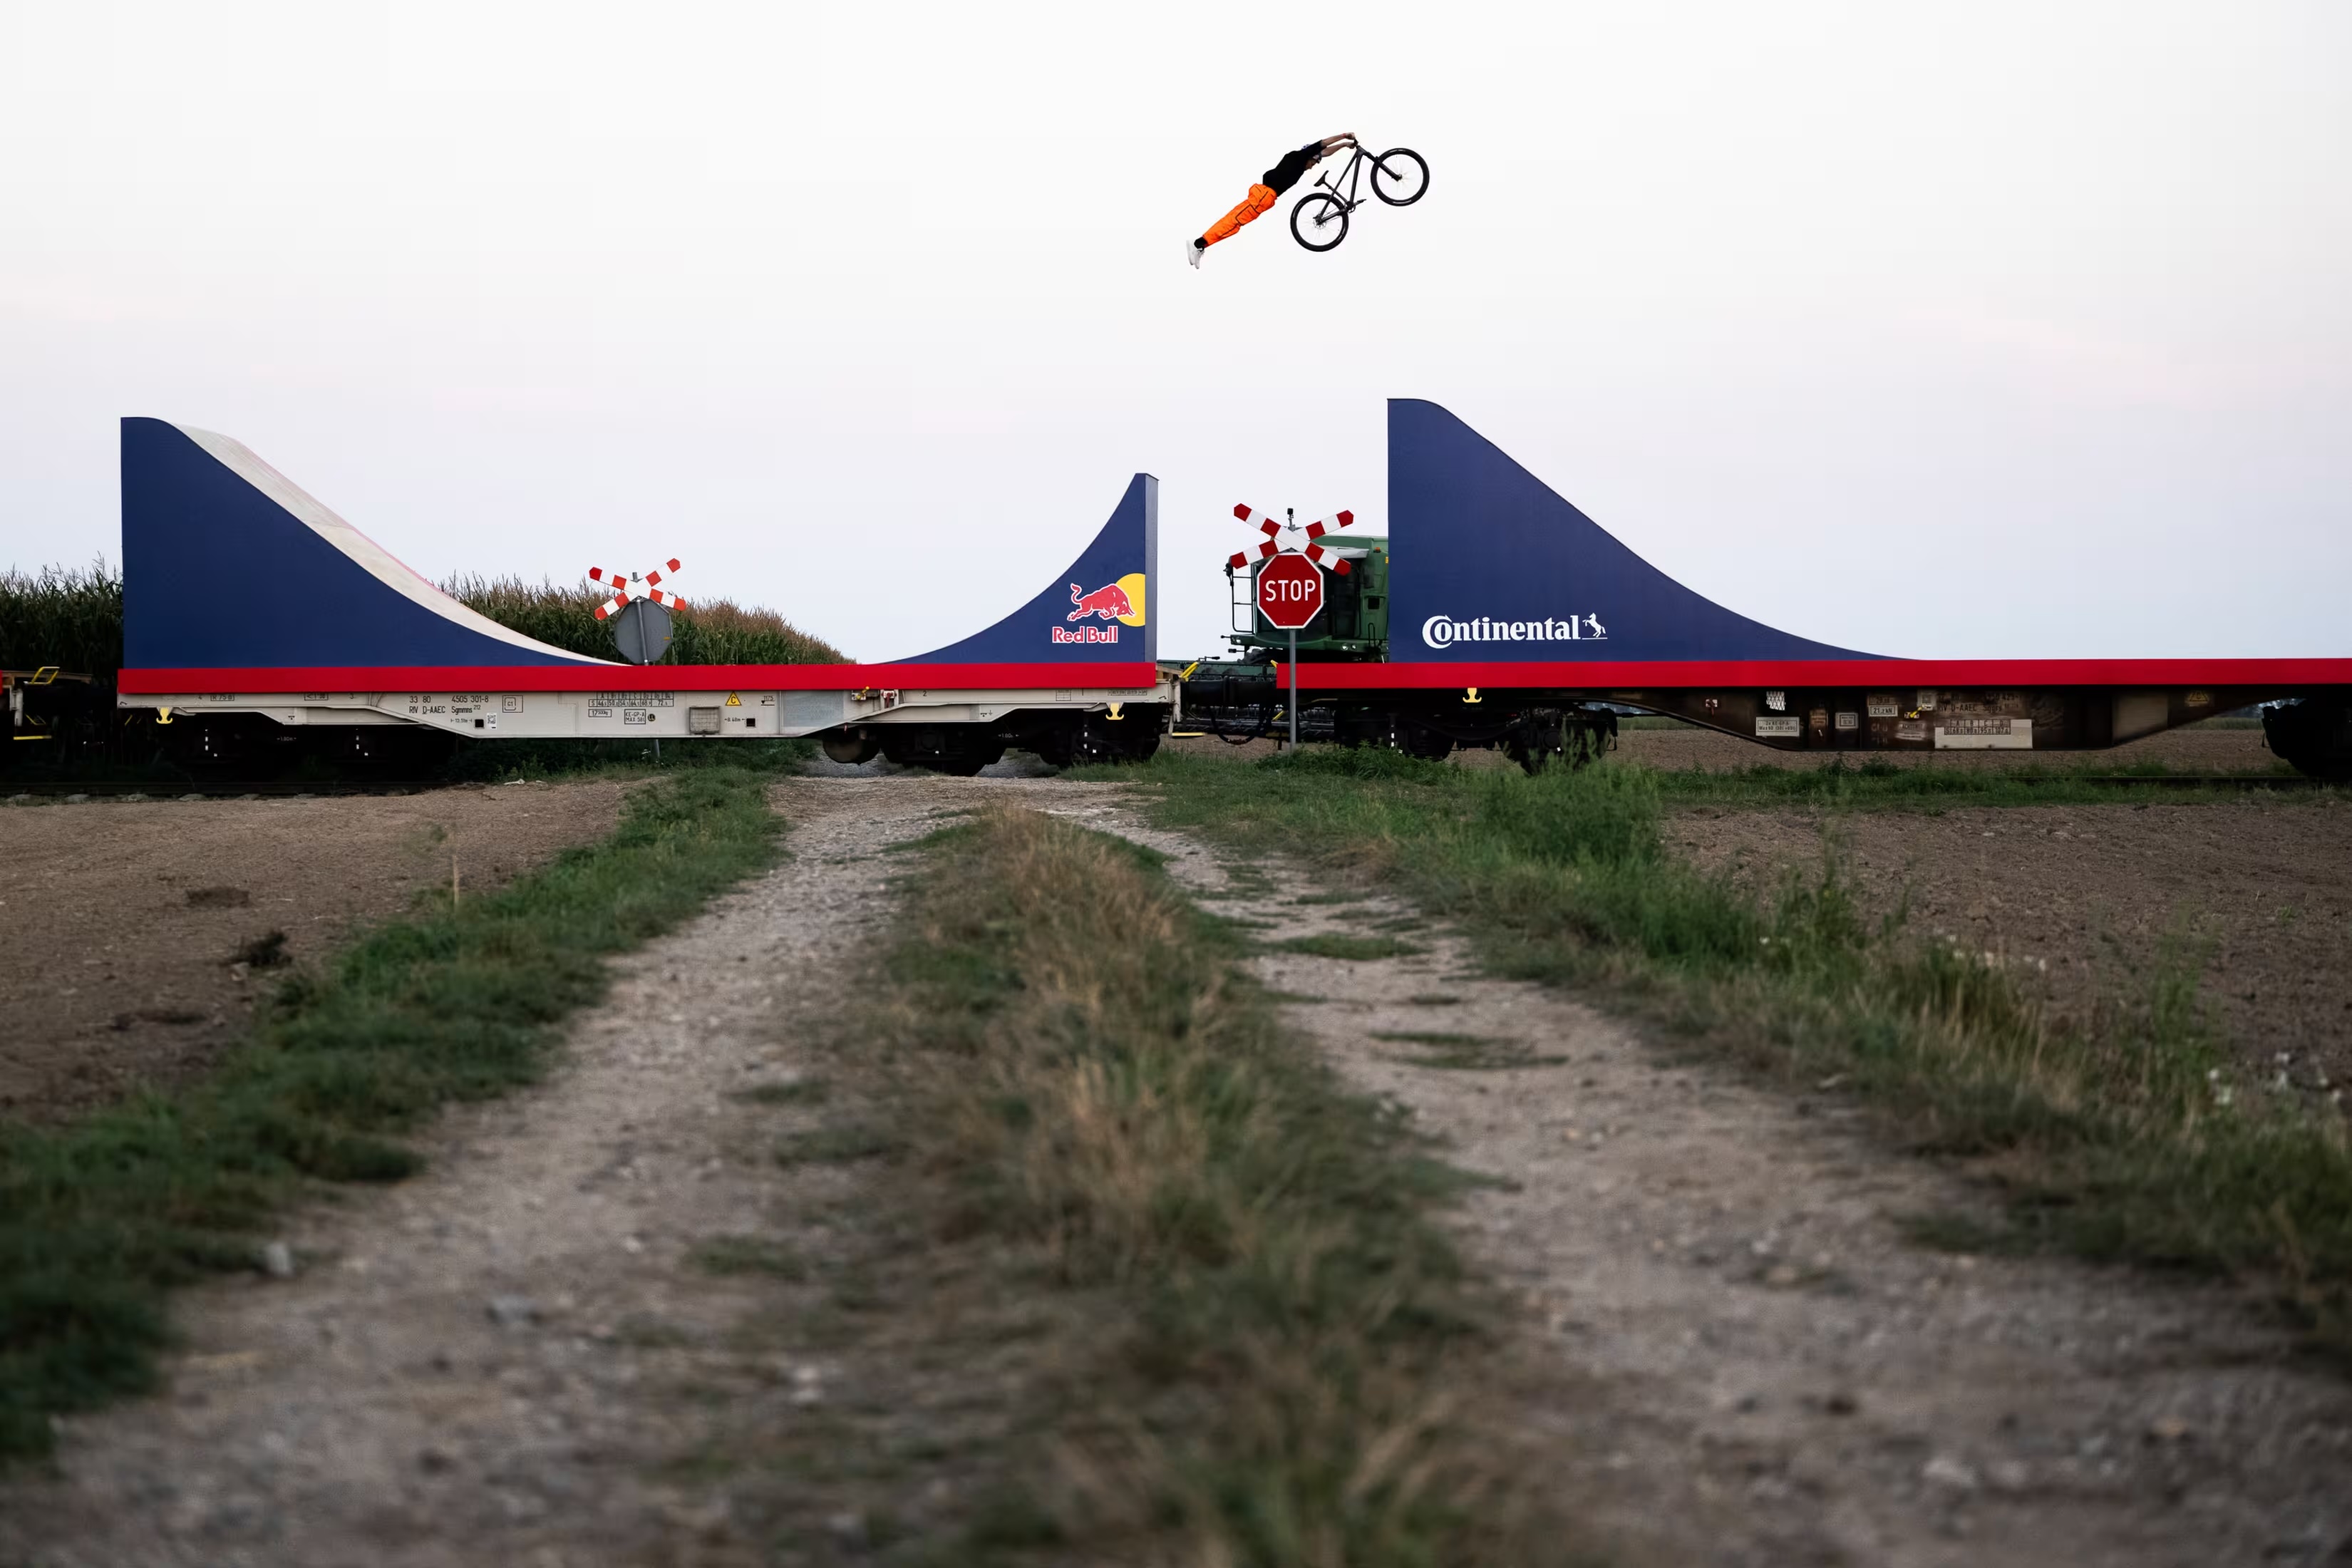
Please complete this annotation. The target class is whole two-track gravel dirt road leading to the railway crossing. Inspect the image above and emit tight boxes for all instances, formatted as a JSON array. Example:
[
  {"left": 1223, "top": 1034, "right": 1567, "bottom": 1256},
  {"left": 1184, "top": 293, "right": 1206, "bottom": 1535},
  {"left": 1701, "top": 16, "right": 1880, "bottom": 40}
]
[{"left": 0, "top": 775, "right": 2352, "bottom": 1568}]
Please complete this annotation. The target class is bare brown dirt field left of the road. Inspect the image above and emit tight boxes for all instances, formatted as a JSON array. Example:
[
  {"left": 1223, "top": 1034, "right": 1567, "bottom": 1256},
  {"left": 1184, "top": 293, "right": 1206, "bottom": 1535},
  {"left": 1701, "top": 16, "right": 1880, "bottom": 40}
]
[{"left": 0, "top": 780, "right": 626, "bottom": 1117}]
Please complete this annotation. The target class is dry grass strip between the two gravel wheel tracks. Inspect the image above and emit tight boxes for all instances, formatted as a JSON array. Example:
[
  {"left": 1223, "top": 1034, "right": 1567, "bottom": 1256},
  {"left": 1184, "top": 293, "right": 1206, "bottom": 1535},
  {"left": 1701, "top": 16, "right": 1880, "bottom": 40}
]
[{"left": 847, "top": 809, "right": 1564, "bottom": 1568}]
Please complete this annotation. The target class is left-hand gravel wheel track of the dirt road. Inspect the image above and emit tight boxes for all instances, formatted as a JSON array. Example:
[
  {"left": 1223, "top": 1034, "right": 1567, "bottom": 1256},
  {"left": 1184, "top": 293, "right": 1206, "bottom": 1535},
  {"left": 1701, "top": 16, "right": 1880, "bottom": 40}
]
[{"left": 0, "top": 780, "right": 969, "bottom": 1568}]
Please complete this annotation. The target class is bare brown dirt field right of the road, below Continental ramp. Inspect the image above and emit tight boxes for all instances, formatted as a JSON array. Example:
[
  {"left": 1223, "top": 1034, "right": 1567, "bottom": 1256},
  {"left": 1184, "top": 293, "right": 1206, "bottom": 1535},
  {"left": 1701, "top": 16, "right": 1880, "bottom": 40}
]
[{"left": 1668, "top": 797, "right": 2352, "bottom": 1093}]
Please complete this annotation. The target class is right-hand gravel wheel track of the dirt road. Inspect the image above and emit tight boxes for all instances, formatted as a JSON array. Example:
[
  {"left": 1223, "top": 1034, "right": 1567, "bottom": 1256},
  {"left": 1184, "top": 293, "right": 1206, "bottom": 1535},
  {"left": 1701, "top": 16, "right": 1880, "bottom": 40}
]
[{"left": 1044, "top": 799, "right": 2352, "bottom": 1568}]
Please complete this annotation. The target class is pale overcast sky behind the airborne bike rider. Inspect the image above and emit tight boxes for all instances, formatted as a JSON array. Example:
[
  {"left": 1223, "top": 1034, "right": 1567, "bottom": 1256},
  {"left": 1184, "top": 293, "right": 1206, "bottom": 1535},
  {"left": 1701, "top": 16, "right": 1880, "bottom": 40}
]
[{"left": 0, "top": 0, "right": 2352, "bottom": 659}]
